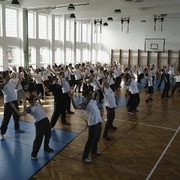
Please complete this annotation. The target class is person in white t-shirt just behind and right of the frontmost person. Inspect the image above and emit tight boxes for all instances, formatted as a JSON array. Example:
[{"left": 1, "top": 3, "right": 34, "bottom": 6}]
[{"left": 103, "top": 81, "right": 117, "bottom": 140}]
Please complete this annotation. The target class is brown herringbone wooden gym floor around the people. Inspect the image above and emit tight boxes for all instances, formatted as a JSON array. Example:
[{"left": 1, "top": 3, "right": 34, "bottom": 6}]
[{"left": 0, "top": 83, "right": 180, "bottom": 180}]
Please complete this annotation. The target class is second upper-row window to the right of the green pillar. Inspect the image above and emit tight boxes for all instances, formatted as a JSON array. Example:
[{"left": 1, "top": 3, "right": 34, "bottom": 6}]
[{"left": 38, "top": 14, "right": 48, "bottom": 39}]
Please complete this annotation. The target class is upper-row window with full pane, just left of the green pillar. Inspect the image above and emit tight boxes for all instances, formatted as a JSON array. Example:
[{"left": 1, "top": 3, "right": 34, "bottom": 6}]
[{"left": 5, "top": 8, "right": 18, "bottom": 37}]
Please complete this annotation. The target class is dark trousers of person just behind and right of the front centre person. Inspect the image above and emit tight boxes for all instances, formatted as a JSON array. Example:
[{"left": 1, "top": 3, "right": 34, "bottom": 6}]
[{"left": 103, "top": 106, "right": 115, "bottom": 136}]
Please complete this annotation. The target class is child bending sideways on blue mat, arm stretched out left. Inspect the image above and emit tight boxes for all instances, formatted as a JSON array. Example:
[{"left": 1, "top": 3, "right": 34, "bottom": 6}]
[{"left": 11, "top": 95, "right": 53, "bottom": 160}]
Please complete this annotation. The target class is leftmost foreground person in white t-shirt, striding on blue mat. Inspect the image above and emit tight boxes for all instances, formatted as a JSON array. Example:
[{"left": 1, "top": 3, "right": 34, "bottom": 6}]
[{"left": 0, "top": 72, "right": 24, "bottom": 140}]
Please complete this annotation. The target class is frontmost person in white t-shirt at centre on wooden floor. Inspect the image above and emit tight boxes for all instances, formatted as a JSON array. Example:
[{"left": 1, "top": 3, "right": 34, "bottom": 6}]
[{"left": 70, "top": 89, "right": 102, "bottom": 163}]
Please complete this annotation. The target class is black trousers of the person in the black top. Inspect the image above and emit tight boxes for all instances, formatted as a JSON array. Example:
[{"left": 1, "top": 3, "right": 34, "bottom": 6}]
[{"left": 51, "top": 102, "right": 62, "bottom": 128}]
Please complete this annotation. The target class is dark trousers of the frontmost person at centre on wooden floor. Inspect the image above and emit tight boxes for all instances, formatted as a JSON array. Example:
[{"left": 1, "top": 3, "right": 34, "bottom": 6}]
[{"left": 82, "top": 122, "right": 102, "bottom": 159}]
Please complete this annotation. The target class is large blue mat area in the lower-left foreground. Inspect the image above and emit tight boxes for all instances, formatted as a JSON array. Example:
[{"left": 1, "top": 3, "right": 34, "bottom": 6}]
[{"left": 0, "top": 118, "right": 78, "bottom": 180}]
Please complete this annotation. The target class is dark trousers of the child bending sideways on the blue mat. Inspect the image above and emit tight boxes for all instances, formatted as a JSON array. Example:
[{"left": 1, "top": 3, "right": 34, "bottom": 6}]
[{"left": 31, "top": 118, "right": 51, "bottom": 157}]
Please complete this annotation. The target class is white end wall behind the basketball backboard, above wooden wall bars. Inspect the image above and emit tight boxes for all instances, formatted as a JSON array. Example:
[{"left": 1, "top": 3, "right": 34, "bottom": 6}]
[{"left": 102, "top": 18, "right": 180, "bottom": 56}]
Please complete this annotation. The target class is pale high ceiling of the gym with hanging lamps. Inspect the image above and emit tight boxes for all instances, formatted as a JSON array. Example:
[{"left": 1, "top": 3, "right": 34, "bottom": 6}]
[{"left": 0, "top": 0, "right": 180, "bottom": 20}]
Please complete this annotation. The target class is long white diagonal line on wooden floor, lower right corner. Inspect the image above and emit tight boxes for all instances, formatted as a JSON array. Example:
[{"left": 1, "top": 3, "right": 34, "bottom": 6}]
[{"left": 146, "top": 126, "right": 180, "bottom": 180}]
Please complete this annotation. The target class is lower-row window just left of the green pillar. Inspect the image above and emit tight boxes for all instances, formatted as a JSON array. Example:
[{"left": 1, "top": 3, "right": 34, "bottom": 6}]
[{"left": 6, "top": 46, "right": 20, "bottom": 65}]
